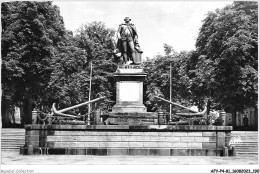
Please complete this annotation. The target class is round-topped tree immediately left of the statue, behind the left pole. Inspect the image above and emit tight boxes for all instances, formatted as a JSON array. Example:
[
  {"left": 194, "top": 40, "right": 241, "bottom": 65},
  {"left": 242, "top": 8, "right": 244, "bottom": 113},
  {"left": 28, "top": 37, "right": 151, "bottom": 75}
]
[{"left": 75, "top": 21, "right": 117, "bottom": 104}]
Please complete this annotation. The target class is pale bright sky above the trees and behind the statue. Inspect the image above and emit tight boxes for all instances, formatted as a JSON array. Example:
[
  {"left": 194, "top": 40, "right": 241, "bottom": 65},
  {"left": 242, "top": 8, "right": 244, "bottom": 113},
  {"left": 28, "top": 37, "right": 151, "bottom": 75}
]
[{"left": 53, "top": 0, "right": 232, "bottom": 58}]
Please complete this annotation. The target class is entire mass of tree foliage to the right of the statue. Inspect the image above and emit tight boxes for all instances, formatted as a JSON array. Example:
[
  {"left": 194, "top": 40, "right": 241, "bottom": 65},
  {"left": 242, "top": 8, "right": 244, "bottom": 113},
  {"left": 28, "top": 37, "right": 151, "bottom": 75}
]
[{"left": 144, "top": 2, "right": 258, "bottom": 117}]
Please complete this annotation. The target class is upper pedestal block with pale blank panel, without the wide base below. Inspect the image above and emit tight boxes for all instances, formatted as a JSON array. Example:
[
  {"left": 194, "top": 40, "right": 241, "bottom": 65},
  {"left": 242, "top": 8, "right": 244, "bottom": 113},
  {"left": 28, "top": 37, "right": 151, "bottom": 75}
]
[{"left": 112, "top": 65, "right": 147, "bottom": 113}]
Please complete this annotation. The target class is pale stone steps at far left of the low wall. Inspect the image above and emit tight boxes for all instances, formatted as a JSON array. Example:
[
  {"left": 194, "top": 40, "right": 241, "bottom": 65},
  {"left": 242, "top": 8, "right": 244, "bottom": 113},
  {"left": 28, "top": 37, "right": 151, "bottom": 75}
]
[{"left": 1, "top": 128, "right": 25, "bottom": 151}]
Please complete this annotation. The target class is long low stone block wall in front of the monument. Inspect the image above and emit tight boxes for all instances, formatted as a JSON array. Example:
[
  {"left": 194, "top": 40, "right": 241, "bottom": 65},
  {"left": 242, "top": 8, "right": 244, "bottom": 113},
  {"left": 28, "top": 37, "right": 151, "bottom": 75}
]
[{"left": 23, "top": 125, "right": 232, "bottom": 155}]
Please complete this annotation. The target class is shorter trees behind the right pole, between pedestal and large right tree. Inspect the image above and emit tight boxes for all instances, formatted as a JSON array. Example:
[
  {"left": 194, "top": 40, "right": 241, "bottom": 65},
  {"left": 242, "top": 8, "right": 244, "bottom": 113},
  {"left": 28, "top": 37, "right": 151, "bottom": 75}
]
[{"left": 143, "top": 44, "right": 190, "bottom": 111}]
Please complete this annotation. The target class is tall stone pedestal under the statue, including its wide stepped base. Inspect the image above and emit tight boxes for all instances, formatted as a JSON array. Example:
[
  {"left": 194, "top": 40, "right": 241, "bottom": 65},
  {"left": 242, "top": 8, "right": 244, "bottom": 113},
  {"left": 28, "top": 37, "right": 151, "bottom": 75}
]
[{"left": 106, "top": 65, "right": 158, "bottom": 125}]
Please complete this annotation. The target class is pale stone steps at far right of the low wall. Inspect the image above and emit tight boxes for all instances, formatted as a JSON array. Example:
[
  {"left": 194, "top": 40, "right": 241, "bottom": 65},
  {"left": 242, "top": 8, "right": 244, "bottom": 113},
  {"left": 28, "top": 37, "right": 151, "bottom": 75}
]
[{"left": 230, "top": 131, "right": 258, "bottom": 155}]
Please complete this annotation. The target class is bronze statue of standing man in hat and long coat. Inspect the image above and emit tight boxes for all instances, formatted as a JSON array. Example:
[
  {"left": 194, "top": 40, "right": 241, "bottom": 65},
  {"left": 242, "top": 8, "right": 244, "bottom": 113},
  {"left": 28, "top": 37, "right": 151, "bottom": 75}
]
[{"left": 117, "top": 17, "right": 142, "bottom": 65}]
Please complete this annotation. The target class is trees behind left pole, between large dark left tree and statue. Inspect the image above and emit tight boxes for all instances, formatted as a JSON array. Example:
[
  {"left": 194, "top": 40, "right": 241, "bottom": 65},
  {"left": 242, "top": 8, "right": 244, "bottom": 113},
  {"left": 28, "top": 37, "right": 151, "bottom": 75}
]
[{"left": 49, "top": 22, "right": 117, "bottom": 114}]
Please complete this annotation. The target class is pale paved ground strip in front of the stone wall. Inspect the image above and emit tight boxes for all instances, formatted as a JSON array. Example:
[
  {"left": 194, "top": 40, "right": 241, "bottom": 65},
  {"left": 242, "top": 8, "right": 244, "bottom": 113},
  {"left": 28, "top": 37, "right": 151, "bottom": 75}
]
[{"left": 1, "top": 151, "right": 259, "bottom": 165}]
